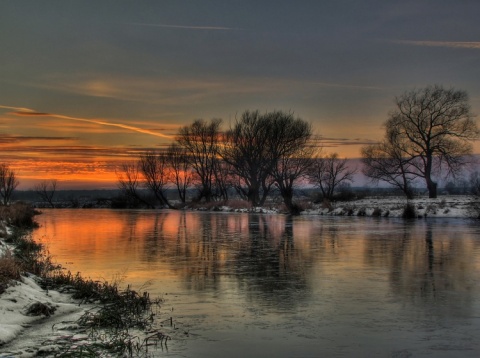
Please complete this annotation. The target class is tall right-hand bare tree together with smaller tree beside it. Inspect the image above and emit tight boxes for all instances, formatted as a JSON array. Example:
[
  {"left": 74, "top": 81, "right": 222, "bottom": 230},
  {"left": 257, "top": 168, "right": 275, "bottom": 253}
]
[{"left": 362, "top": 85, "right": 479, "bottom": 198}]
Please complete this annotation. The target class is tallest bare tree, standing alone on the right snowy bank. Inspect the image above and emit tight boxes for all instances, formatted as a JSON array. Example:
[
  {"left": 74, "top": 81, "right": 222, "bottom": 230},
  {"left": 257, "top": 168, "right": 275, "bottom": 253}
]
[{"left": 385, "top": 85, "right": 479, "bottom": 198}]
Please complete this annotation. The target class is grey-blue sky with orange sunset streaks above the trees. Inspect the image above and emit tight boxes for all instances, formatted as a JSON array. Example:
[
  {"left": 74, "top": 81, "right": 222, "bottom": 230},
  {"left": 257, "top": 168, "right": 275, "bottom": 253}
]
[{"left": 0, "top": 0, "right": 480, "bottom": 189}]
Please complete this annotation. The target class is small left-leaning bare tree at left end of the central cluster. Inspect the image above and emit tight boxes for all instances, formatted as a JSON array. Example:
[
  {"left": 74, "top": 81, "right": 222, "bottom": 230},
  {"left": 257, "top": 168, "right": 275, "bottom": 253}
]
[{"left": 117, "top": 162, "right": 153, "bottom": 207}]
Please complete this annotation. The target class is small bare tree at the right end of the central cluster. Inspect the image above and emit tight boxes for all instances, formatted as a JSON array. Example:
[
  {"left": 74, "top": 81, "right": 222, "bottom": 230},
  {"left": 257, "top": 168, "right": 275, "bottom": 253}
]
[{"left": 309, "top": 153, "right": 357, "bottom": 200}]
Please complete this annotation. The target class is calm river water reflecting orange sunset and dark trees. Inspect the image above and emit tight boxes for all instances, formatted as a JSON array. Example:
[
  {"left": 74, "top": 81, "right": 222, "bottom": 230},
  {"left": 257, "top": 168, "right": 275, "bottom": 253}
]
[{"left": 34, "top": 210, "right": 480, "bottom": 358}]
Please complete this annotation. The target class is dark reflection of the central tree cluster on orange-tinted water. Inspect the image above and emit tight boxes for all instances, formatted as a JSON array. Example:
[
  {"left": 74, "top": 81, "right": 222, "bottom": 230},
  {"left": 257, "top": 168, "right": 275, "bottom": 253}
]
[{"left": 130, "top": 212, "right": 313, "bottom": 308}]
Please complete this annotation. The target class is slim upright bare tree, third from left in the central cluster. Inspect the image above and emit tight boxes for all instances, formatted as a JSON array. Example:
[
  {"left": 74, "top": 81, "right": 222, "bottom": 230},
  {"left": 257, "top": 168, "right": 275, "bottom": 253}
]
[{"left": 167, "top": 143, "right": 192, "bottom": 203}]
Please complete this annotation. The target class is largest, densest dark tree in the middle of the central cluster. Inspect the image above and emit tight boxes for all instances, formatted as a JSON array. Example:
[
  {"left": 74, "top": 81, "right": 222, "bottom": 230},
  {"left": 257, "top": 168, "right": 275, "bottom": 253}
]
[{"left": 221, "top": 111, "right": 311, "bottom": 206}]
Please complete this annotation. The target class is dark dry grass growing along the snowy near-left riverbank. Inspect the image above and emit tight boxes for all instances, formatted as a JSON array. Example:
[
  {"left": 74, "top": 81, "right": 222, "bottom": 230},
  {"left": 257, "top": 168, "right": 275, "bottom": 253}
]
[{"left": 0, "top": 203, "right": 172, "bottom": 357}]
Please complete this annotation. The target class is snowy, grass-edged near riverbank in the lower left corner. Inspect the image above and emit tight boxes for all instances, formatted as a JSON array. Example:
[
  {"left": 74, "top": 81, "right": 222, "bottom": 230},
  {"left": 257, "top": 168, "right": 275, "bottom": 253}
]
[{"left": 0, "top": 204, "right": 169, "bottom": 357}]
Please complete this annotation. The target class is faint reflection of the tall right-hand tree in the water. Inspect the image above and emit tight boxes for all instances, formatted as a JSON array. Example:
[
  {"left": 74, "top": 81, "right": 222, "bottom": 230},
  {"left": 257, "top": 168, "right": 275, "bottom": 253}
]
[{"left": 365, "top": 221, "right": 476, "bottom": 317}]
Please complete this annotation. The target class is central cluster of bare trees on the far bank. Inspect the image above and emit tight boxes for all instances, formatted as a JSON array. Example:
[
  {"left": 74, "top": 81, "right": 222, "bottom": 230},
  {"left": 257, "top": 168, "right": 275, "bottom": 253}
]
[{"left": 118, "top": 111, "right": 355, "bottom": 212}]
